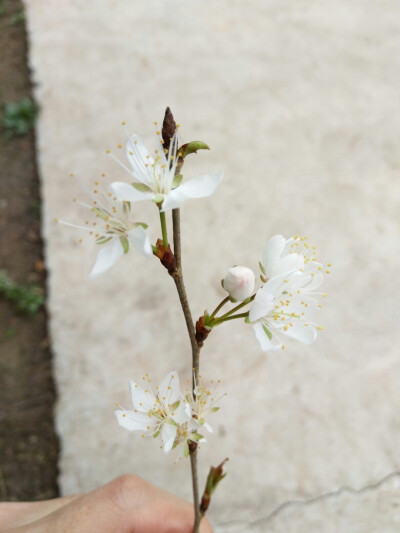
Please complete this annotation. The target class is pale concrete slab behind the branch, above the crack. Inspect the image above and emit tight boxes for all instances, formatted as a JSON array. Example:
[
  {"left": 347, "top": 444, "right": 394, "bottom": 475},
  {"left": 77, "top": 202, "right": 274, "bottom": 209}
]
[{"left": 26, "top": 0, "right": 400, "bottom": 533}]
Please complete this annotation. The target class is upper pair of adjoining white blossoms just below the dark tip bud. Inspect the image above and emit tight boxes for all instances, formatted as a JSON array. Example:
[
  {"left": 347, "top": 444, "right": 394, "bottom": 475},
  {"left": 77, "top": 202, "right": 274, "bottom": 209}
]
[{"left": 60, "top": 123, "right": 222, "bottom": 278}]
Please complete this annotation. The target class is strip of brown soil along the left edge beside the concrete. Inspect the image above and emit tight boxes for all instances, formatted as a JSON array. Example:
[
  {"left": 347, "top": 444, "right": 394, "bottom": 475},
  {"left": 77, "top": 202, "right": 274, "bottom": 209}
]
[{"left": 0, "top": 0, "right": 58, "bottom": 501}]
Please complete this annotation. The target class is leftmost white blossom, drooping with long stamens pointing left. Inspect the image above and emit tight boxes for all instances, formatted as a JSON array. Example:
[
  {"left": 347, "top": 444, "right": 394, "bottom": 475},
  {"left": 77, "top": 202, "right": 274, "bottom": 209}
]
[{"left": 59, "top": 181, "right": 152, "bottom": 278}]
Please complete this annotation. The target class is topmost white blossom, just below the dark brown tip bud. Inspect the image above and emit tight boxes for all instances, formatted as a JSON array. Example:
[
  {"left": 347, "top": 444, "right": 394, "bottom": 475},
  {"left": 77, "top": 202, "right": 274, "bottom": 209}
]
[{"left": 110, "top": 133, "right": 222, "bottom": 211}]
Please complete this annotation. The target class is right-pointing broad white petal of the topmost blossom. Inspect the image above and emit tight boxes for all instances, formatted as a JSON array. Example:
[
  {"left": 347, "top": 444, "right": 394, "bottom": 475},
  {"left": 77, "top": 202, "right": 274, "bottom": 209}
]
[{"left": 162, "top": 171, "right": 223, "bottom": 211}]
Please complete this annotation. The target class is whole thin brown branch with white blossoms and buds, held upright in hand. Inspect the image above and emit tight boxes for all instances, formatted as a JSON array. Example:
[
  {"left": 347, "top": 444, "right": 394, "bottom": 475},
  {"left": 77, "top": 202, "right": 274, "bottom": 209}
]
[{"left": 60, "top": 104, "right": 331, "bottom": 533}]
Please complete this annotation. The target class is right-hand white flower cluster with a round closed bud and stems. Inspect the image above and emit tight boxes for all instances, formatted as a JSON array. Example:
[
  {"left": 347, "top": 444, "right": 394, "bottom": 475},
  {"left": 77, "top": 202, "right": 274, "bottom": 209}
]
[{"left": 217, "top": 235, "right": 330, "bottom": 351}]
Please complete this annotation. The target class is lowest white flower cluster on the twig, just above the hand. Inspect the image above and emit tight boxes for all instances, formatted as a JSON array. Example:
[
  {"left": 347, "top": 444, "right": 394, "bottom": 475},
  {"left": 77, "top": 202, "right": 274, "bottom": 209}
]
[{"left": 115, "top": 371, "right": 222, "bottom": 457}]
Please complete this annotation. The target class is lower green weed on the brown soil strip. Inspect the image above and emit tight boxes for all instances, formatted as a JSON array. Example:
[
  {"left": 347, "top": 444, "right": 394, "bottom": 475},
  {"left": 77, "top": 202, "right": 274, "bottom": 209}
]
[{"left": 0, "top": 270, "right": 44, "bottom": 316}]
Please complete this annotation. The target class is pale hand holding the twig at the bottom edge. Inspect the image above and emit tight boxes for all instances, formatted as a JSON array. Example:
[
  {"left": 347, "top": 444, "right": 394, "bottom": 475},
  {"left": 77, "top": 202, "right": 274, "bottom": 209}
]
[{"left": 0, "top": 475, "right": 213, "bottom": 533}]
